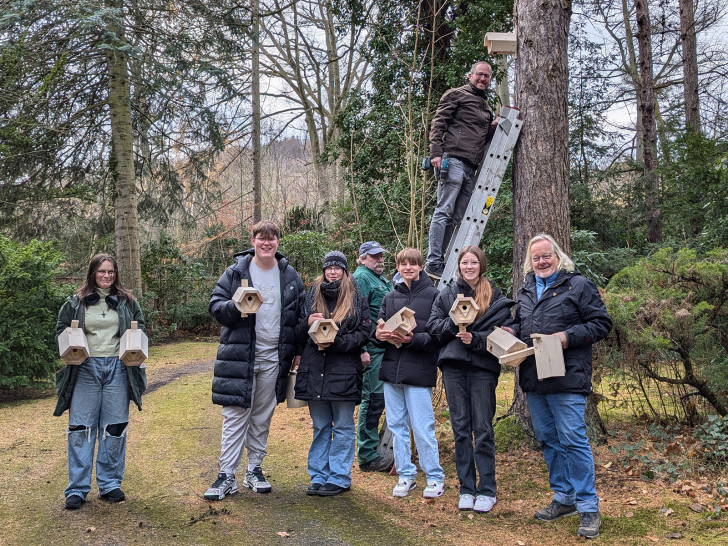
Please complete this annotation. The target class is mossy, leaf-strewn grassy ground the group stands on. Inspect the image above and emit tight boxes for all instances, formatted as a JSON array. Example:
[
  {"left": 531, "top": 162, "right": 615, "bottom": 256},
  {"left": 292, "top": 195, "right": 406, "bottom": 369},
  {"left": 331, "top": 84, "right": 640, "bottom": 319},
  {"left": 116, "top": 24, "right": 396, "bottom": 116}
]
[{"left": 0, "top": 343, "right": 728, "bottom": 545}]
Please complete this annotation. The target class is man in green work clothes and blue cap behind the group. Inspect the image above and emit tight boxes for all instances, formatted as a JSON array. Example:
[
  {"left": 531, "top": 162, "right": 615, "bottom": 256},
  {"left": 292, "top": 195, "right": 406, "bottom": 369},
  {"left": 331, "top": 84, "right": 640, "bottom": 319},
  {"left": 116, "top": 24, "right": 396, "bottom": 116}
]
[{"left": 353, "top": 241, "right": 394, "bottom": 472}]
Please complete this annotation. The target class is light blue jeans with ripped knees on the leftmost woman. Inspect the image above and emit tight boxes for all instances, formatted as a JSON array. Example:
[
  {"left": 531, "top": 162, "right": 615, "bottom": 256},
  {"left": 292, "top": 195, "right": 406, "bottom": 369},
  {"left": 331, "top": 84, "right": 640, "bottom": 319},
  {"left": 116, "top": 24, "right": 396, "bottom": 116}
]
[{"left": 65, "top": 356, "right": 129, "bottom": 499}]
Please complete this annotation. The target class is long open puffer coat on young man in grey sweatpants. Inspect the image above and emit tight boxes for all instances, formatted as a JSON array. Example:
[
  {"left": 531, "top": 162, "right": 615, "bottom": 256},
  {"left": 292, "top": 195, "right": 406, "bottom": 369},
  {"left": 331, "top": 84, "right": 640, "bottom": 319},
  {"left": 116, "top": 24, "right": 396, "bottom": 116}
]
[{"left": 209, "top": 248, "right": 305, "bottom": 408}]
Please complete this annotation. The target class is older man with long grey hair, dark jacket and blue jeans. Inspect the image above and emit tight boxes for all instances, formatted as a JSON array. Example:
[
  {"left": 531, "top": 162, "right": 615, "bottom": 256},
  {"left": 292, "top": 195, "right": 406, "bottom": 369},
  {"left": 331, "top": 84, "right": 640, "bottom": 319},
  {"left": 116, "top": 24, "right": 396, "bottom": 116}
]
[{"left": 506, "top": 233, "right": 612, "bottom": 538}]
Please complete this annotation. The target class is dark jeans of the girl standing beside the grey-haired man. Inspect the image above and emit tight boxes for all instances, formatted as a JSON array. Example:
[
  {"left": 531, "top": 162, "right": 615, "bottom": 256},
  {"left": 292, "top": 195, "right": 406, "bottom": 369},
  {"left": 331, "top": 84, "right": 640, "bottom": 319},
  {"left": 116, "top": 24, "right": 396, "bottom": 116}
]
[{"left": 442, "top": 366, "right": 498, "bottom": 497}]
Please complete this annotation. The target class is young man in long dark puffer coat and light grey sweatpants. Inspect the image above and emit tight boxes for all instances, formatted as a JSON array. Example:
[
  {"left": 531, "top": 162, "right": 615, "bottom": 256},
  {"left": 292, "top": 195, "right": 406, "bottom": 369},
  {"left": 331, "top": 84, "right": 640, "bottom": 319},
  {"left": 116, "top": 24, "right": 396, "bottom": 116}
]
[{"left": 205, "top": 221, "right": 305, "bottom": 500}]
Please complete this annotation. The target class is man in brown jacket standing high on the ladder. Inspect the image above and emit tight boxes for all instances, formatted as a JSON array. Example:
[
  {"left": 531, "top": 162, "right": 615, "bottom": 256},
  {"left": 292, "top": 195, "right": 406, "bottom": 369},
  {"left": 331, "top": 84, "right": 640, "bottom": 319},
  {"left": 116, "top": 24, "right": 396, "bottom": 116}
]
[{"left": 425, "top": 62, "right": 498, "bottom": 279}]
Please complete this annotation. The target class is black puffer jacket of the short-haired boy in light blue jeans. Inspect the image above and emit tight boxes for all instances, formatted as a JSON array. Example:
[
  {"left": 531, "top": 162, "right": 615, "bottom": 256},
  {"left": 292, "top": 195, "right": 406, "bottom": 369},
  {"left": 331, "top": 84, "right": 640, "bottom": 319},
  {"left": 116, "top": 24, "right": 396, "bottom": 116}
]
[{"left": 371, "top": 273, "right": 439, "bottom": 387}]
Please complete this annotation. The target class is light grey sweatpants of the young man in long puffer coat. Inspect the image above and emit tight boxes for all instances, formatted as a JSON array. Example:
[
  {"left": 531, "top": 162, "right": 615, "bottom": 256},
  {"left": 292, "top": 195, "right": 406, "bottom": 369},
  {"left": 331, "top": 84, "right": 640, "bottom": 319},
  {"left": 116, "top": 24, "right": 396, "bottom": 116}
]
[{"left": 220, "top": 356, "right": 278, "bottom": 474}]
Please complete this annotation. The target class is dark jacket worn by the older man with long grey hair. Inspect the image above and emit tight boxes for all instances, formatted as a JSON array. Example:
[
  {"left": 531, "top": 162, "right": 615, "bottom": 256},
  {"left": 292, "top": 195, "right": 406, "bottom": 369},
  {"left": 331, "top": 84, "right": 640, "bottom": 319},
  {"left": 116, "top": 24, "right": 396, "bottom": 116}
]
[{"left": 512, "top": 271, "right": 612, "bottom": 395}]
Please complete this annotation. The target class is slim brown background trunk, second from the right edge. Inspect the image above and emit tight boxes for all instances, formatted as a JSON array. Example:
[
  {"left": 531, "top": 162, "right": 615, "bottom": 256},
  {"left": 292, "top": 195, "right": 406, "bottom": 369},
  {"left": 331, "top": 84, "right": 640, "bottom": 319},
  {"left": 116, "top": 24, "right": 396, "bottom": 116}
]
[{"left": 634, "top": 0, "right": 662, "bottom": 243}]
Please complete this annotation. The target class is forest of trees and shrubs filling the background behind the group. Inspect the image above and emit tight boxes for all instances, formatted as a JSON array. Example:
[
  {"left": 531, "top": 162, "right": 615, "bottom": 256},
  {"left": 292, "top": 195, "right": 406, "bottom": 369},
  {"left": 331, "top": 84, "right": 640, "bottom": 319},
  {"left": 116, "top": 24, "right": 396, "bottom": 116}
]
[{"left": 0, "top": 0, "right": 728, "bottom": 426}]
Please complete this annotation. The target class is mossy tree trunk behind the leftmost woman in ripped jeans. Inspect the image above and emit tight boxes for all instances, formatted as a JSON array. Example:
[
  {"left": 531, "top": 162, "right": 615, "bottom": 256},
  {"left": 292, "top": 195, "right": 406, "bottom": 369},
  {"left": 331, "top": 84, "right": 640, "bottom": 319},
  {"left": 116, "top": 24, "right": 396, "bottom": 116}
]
[{"left": 106, "top": 1, "right": 142, "bottom": 297}]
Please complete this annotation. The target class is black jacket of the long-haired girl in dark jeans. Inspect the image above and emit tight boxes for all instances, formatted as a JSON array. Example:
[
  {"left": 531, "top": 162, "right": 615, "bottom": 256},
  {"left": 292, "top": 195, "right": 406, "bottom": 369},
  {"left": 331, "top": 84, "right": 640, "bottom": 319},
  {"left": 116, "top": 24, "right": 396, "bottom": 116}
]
[{"left": 427, "top": 279, "right": 515, "bottom": 375}]
